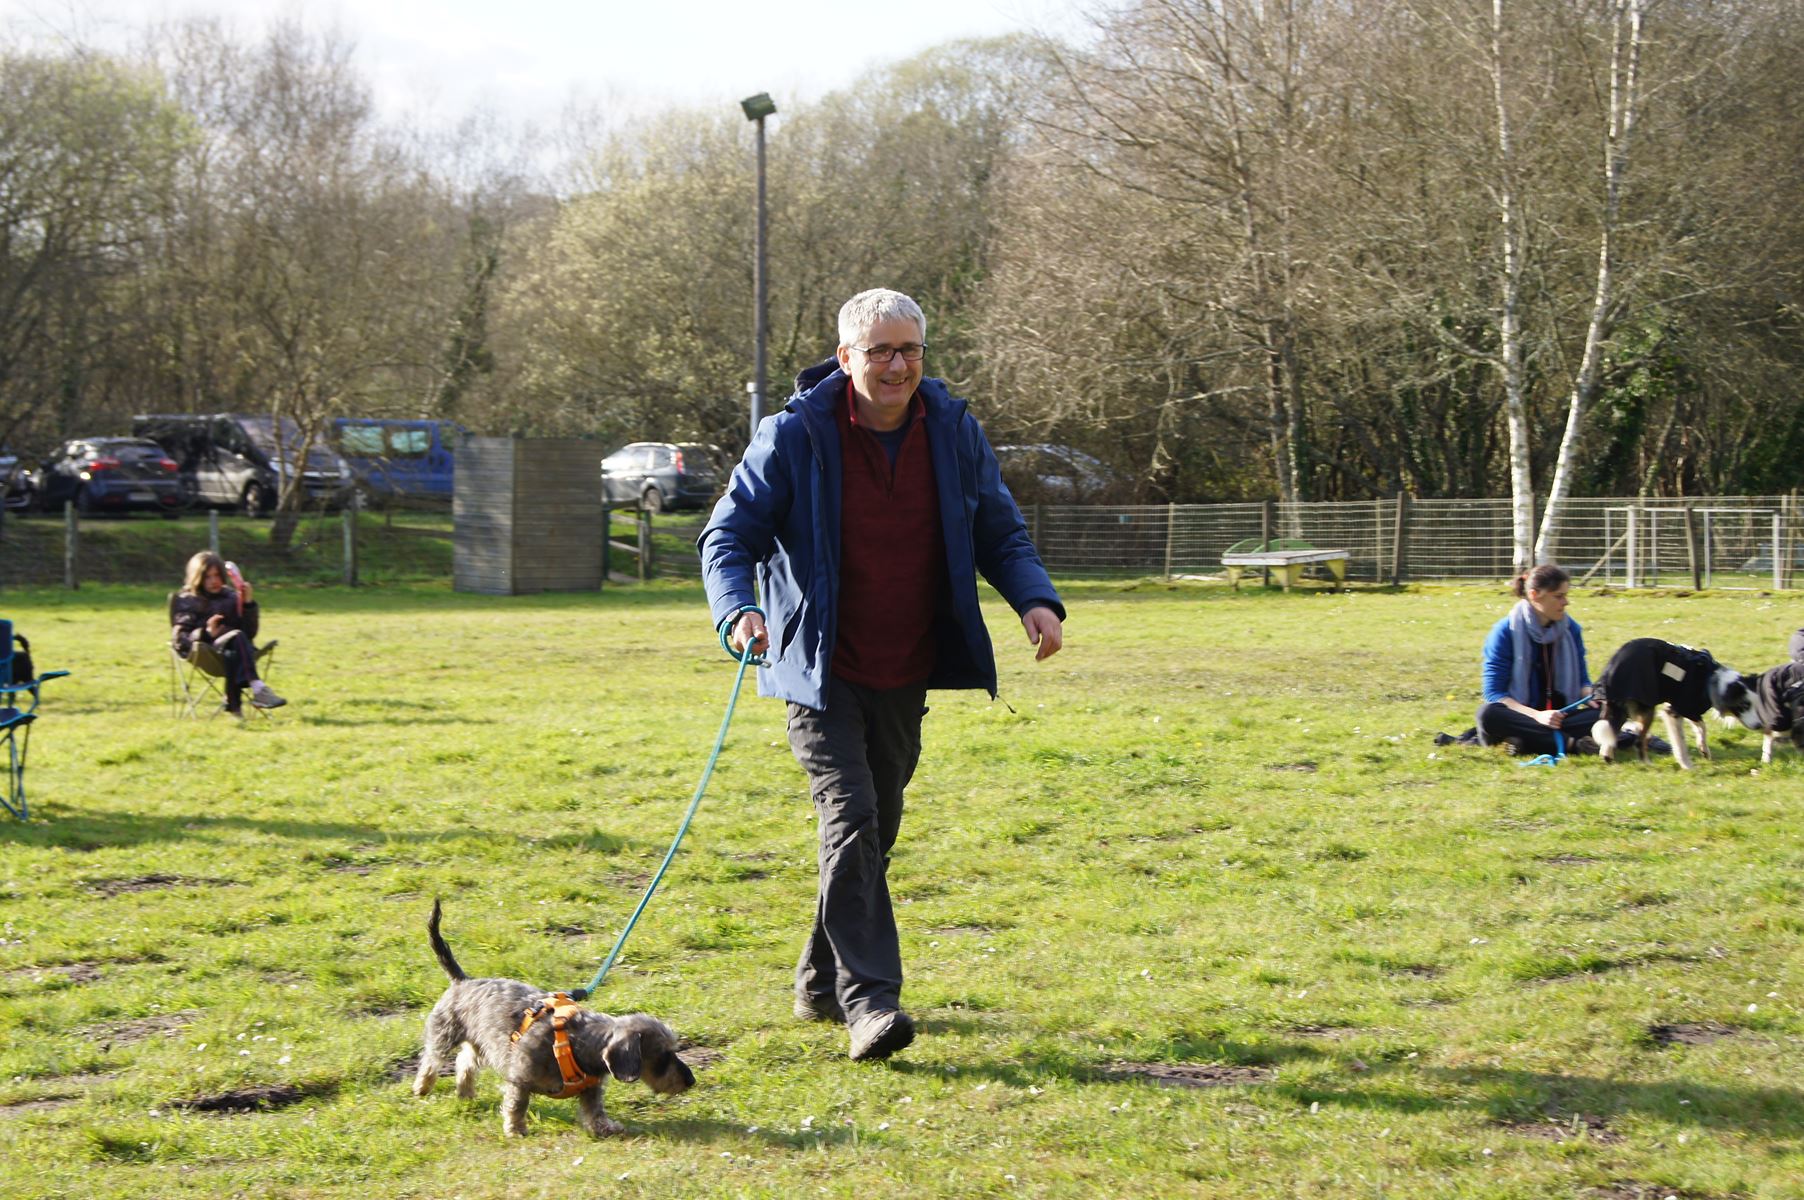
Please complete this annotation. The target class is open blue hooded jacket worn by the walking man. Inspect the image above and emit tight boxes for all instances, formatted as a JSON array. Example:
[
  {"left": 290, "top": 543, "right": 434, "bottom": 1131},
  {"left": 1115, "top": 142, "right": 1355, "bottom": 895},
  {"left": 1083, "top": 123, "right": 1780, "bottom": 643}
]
[{"left": 696, "top": 363, "right": 1064, "bottom": 709}]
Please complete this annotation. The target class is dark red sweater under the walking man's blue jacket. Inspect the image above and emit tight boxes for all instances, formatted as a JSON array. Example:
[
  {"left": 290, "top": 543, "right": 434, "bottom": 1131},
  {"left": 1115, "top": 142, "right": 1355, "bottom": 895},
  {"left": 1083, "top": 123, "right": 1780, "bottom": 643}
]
[{"left": 833, "top": 383, "right": 945, "bottom": 688}]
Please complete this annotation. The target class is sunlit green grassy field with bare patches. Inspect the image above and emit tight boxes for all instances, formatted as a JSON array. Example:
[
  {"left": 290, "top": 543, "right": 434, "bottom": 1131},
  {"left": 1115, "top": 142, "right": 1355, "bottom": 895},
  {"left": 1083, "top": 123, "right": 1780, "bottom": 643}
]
[{"left": 0, "top": 583, "right": 1804, "bottom": 1200}]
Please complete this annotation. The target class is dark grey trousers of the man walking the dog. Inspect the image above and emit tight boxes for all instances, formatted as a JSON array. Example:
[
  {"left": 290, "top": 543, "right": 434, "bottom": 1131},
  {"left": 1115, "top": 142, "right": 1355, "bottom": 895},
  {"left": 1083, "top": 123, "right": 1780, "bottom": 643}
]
[{"left": 788, "top": 678, "right": 927, "bottom": 1021}]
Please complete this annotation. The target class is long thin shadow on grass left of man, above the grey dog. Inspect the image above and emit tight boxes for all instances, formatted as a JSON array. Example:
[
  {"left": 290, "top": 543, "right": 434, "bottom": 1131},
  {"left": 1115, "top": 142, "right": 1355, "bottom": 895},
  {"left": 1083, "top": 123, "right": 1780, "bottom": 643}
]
[{"left": 0, "top": 799, "right": 642, "bottom": 854}]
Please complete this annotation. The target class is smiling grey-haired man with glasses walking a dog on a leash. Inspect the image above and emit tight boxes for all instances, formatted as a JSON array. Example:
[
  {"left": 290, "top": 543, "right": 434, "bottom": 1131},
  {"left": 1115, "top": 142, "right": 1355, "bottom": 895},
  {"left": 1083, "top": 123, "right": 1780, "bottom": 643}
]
[{"left": 698, "top": 289, "right": 1064, "bottom": 1059}]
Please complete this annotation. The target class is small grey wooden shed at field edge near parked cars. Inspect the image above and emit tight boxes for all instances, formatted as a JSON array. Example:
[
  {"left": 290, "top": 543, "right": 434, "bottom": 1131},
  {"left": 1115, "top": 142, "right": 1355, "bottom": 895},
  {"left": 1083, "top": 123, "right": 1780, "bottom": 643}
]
[{"left": 451, "top": 437, "right": 606, "bottom": 595}]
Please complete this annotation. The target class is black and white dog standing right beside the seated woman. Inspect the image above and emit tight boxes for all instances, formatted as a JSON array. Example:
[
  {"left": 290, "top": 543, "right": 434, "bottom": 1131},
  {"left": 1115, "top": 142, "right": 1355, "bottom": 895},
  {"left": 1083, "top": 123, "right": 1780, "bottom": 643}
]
[{"left": 1591, "top": 637, "right": 1759, "bottom": 771}]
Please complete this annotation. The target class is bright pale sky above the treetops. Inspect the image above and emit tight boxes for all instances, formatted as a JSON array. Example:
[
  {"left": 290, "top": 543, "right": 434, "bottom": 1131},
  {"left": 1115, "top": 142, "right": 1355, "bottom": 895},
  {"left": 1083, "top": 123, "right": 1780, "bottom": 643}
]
[{"left": 0, "top": 0, "right": 1095, "bottom": 125}]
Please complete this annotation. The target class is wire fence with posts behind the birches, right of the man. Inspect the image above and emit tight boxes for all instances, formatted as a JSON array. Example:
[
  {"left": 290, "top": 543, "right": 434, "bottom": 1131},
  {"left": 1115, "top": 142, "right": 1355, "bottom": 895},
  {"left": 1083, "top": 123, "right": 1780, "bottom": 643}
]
[{"left": 1026, "top": 496, "right": 1804, "bottom": 588}]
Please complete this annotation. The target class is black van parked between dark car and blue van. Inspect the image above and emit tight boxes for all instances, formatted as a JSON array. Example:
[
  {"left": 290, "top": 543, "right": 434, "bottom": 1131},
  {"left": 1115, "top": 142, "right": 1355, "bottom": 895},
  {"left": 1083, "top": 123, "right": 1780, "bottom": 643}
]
[{"left": 132, "top": 413, "right": 352, "bottom": 516}]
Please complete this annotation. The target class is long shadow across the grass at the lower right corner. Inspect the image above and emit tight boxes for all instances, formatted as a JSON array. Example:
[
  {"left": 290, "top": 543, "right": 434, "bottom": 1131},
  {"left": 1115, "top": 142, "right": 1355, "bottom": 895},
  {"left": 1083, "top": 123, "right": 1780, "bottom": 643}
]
[{"left": 1275, "top": 1065, "right": 1804, "bottom": 1137}]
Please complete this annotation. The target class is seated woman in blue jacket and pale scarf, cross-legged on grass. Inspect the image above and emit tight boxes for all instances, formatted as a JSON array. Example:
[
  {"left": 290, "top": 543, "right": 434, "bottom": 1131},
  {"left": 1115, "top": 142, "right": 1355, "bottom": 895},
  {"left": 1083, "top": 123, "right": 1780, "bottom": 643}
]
[{"left": 1477, "top": 563, "right": 1598, "bottom": 754}]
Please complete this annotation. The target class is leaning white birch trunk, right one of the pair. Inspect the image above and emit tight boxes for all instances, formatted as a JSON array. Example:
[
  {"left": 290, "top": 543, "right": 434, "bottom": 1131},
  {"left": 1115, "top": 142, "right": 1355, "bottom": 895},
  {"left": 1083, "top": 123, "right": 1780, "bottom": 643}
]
[{"left": 1535, "top": 0, "right": 1647, "bottom": 563}]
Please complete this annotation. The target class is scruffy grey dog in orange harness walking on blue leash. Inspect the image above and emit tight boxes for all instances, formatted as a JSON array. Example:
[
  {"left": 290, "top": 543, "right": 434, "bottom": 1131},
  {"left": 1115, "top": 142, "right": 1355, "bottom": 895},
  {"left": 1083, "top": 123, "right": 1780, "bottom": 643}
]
[{"left": 413, "top": 900, "right": 695, "bottom": 1137}]
